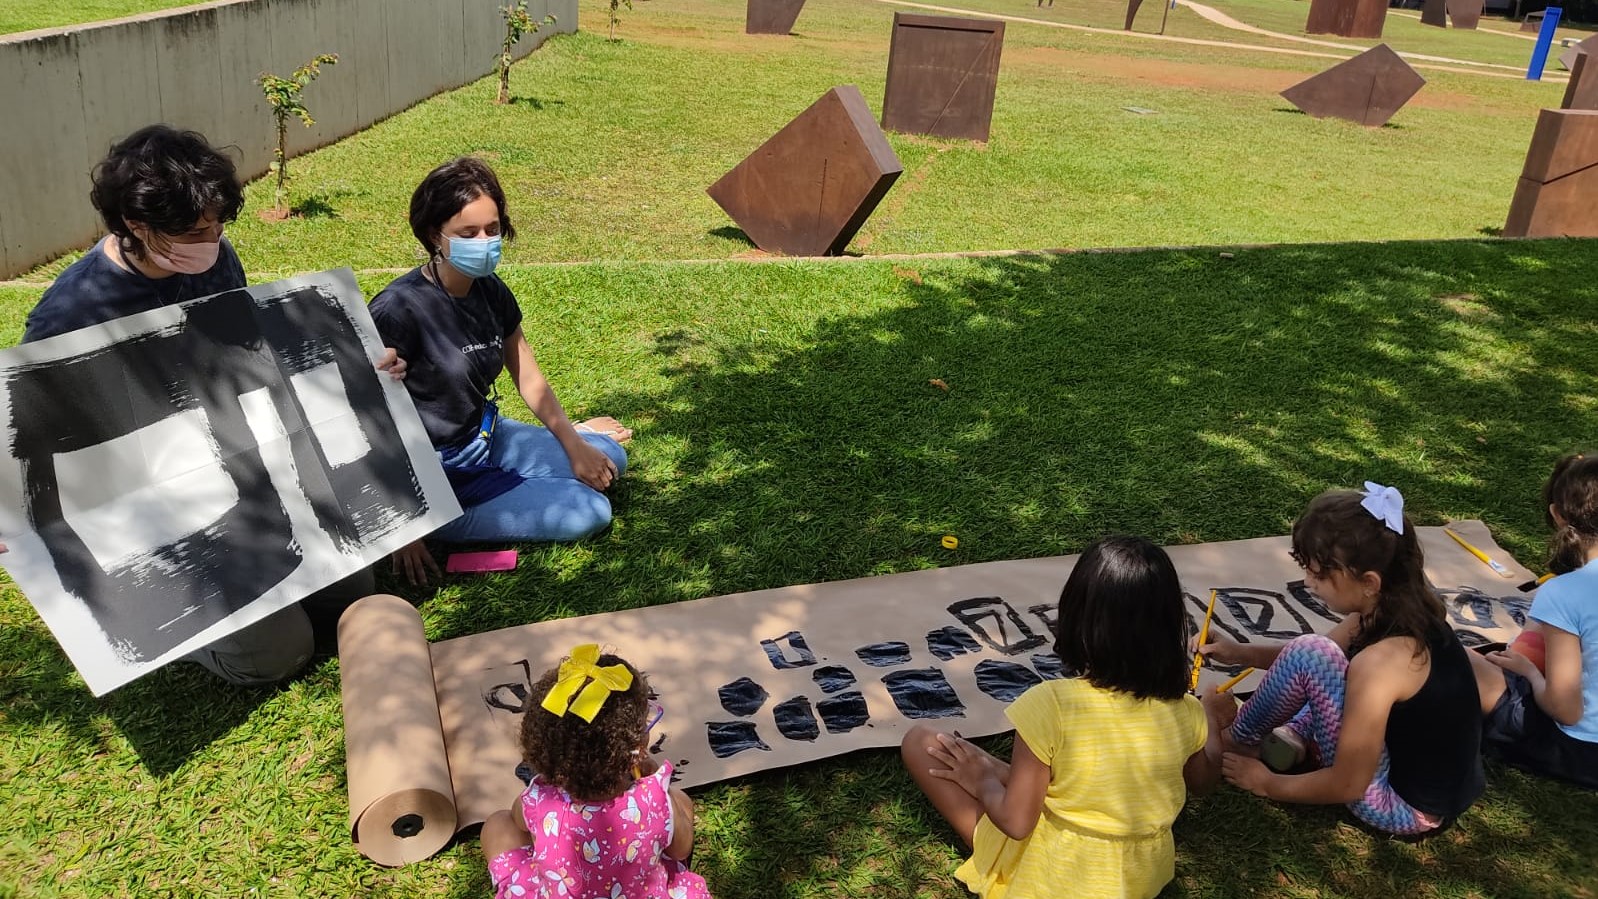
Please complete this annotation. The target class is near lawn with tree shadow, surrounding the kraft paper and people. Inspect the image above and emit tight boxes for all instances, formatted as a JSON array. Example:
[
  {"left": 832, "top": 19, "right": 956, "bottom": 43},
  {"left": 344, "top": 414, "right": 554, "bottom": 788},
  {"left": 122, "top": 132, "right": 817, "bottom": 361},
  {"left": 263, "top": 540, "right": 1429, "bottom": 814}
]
[{"left": 0, "top": 241, "right": 1598, "bottom": 897}]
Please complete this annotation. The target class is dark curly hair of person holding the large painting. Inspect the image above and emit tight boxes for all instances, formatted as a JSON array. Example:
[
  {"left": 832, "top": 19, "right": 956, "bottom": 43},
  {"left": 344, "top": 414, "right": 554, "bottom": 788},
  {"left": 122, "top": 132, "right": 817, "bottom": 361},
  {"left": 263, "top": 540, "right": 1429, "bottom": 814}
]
[{"left": 89, "top": 125, "right": 244, "bottom": 259}]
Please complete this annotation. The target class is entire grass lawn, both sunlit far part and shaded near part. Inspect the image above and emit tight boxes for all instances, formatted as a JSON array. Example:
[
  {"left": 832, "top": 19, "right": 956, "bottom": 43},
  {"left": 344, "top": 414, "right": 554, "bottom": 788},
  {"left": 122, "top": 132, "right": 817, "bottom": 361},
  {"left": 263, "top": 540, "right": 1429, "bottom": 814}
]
[{"left": 9, "top": 0, "right": 1598, "bottom": 899}]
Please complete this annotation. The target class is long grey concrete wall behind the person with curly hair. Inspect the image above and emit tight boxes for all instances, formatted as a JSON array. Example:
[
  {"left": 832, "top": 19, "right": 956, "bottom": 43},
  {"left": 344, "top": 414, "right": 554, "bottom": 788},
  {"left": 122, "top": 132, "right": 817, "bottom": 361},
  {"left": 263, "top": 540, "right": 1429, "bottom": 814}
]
[{"left": 0, "top": 0, "right": 577, "bottom": 278}]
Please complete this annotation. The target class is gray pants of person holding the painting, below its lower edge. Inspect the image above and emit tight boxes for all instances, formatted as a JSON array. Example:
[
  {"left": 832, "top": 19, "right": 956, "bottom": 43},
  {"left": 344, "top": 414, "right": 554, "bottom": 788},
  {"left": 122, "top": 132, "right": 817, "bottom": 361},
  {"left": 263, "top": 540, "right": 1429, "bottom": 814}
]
[{"left": 184, "top": 568, "right": 377, "bottom": 687}]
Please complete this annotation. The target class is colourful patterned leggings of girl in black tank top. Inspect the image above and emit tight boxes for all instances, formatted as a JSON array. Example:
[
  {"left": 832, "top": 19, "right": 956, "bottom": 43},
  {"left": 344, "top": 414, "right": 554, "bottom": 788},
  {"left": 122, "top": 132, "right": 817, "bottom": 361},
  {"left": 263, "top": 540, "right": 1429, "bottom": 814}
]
[{"left": 1232, "top": 634, "right": 1440, "bottom": 835}]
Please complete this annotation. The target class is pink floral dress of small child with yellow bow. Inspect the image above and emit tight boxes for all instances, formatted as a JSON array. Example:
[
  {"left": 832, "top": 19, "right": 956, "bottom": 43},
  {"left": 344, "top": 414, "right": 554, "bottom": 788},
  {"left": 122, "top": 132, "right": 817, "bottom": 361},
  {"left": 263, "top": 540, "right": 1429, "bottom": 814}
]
[{"left": 489, "top": 760, "right": 710, "bottom": 899}]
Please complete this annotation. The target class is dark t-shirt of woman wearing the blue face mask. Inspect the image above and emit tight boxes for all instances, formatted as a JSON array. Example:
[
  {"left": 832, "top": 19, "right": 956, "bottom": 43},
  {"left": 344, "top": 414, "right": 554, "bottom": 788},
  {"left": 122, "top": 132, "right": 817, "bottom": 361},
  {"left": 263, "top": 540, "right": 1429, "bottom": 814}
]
[{"left": 371, "top": 268, "right": 521, "bottom": 449}]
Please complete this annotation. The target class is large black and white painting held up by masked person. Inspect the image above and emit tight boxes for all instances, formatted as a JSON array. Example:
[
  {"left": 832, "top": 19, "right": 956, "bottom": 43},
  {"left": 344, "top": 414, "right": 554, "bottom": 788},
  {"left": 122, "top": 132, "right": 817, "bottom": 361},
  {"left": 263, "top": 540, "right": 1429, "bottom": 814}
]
[{"left": 0, "top": 270, "right": 460, "bottom": 695}]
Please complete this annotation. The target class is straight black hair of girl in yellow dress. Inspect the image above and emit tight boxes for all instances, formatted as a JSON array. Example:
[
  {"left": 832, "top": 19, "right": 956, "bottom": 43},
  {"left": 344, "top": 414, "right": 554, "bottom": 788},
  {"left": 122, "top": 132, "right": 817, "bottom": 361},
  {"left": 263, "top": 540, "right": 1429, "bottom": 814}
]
[{"left": 1055, "top": 537, "right": 1187, "bottom": 699}]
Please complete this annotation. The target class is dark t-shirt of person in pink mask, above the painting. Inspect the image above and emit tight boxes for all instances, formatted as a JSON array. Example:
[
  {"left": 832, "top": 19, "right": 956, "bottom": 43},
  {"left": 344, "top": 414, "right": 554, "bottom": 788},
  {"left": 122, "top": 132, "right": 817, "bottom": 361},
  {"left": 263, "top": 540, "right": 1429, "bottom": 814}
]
[{"left": 22, "top": 238, "right": 244, "bottom": 343}]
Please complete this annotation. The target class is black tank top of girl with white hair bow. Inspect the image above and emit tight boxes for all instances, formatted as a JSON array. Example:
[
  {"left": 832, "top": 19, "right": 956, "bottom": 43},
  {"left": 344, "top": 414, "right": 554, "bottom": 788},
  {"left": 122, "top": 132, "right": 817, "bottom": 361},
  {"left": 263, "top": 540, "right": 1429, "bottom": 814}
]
[{"left": 1387, "top": 631, "right": 1486, "bottom": 818}]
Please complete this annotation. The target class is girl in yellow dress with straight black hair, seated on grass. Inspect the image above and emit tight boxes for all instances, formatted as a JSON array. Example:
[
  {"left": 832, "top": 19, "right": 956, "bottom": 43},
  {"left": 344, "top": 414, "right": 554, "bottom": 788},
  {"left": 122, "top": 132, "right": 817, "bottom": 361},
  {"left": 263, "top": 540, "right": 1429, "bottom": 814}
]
[{"left": 901, "top": 537, "right": 1232, "bottom": 899}]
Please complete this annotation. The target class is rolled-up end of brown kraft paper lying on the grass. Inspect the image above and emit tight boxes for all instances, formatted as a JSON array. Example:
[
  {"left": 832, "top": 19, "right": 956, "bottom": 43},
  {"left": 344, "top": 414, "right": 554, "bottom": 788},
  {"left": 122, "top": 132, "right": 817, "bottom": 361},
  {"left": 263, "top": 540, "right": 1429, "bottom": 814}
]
[{"left": 339, "top": 596, "right": 455, "bottom": 867}]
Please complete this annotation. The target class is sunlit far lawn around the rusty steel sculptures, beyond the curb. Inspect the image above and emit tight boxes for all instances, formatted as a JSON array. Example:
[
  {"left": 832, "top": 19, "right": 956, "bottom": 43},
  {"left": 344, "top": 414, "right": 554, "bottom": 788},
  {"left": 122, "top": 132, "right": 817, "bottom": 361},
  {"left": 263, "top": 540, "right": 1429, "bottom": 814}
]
[{"left": 15, "top": 0, "right": 1561, "bottom": 279}]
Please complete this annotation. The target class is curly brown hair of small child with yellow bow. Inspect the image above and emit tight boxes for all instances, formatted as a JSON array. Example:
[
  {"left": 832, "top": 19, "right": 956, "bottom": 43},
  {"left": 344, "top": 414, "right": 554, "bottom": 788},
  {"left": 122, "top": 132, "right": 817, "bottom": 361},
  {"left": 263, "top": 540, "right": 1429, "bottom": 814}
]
[{"left": 521, "top": 653, "right": 649, "bottom": 802}]
